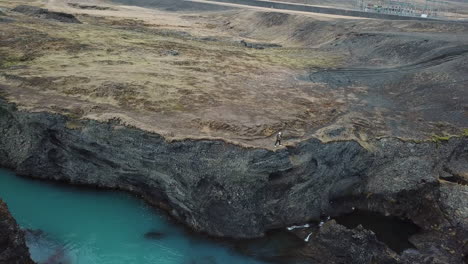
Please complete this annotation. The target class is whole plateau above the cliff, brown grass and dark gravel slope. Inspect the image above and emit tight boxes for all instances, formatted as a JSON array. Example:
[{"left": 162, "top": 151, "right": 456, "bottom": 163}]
[{"left": 0, "top": 0, "right": 468, "bottom": 147}]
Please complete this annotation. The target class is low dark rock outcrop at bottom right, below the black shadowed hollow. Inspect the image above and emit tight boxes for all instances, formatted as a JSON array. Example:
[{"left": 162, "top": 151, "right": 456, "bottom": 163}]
[{"left": 287, "top": 220, "right": 466, "bottom": 264}]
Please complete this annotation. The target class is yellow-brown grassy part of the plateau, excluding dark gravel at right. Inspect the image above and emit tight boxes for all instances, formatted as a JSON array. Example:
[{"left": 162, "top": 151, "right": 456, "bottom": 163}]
[{"left": 0, "top": 0, "right": 466, "bottom": 147}]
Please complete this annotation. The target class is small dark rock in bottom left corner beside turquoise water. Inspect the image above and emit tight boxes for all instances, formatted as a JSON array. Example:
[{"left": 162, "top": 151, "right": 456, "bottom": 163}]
[{"left": 0, "top": 200, "right": 34, "bottom": 264}]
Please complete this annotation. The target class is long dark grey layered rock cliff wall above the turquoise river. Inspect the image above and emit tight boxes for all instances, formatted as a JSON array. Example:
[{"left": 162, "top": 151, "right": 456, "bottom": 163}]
[{"left": 0, "top": 100, "right": 468, "bottom": 263}]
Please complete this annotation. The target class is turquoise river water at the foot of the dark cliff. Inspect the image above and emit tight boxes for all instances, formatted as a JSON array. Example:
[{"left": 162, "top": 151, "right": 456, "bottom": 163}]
[{"left": 0, "top": 169, "right": 264, "bottom": 264}]
